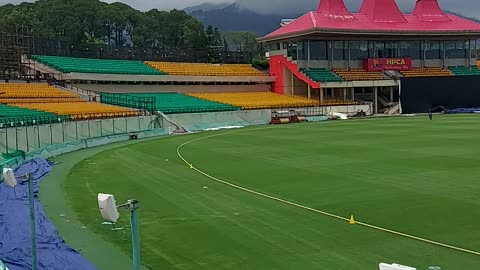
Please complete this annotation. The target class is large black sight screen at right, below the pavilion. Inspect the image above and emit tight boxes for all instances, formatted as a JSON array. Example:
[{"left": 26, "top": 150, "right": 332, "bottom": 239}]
[{"left": 400, "top": 76, "right": 480, "bottom": 114}]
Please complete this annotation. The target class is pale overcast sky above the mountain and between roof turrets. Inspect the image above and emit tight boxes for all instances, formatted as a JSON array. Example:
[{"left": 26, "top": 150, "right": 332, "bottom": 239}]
[{"left": 0, "top": 0, "right": 480, "bottom": 18}]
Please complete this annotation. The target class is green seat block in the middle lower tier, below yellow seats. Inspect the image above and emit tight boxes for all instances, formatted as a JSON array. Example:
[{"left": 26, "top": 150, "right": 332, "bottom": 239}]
[{"left": 100, "top": 93, "right": 240, "bottom": 114}]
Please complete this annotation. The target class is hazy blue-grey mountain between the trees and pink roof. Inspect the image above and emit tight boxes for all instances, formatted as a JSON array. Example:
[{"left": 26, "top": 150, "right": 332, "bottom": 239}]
[{"left": 185, "top": 3, "right": 303, "bottom": 36}]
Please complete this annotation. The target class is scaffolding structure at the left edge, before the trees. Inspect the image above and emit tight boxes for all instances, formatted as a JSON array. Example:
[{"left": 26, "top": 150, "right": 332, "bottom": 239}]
[{"left": 0, "top": 26, "right": 35, "bottom": 80}]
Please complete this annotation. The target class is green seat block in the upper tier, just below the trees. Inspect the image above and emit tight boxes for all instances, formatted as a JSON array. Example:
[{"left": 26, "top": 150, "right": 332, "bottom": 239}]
[{"left": 32, "top": 55, "right": 165, "bottom": 75}]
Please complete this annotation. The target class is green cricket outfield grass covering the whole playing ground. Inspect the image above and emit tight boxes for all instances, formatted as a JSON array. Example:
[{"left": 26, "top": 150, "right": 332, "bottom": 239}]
[{"left": 64, "top": 116, "right": 480, "bottom": 270}]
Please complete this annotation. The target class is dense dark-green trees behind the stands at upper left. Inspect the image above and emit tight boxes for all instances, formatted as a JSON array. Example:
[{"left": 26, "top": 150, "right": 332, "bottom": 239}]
[{"left": 0, "top": 0, "right": 264, "bottom": 62}]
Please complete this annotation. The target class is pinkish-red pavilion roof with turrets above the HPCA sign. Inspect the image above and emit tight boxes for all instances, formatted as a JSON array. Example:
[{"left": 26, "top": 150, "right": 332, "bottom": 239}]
[{"left": 259, "top": 0, "right": 480, "bottom": 42}]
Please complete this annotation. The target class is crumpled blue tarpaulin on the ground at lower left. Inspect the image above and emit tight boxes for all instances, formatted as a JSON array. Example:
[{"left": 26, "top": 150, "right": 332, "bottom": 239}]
[{"left": 0, "top": 159, "right": 96, "bottom": 270}]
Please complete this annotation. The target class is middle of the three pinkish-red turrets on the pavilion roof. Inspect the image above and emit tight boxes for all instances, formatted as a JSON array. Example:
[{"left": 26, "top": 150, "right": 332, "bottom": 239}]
[{"left": 359, "top": 0, "right": 407, "bottom": 23}]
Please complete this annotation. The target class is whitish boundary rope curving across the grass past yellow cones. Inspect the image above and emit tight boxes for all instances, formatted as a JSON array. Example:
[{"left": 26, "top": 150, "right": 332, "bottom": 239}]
[{"left": 177, "top": 127, "right": 480, "bottom": 256}]
